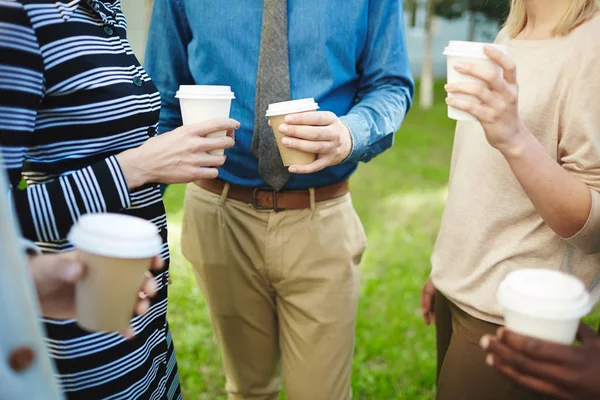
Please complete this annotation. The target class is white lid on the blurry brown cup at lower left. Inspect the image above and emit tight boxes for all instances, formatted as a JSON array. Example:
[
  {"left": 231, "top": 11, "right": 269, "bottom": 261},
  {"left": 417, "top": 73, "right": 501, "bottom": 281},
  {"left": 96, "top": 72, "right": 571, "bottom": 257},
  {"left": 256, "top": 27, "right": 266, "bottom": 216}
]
[{"left": 68, "top": 214, "right": 162, "bottom": 258}]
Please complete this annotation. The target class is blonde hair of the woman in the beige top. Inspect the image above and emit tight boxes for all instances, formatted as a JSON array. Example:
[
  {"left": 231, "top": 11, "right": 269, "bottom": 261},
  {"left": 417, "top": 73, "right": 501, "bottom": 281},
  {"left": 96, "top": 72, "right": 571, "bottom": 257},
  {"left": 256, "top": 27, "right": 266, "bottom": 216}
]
[{"left": 506, "top": 0, "right": 600, "bottom": 38}]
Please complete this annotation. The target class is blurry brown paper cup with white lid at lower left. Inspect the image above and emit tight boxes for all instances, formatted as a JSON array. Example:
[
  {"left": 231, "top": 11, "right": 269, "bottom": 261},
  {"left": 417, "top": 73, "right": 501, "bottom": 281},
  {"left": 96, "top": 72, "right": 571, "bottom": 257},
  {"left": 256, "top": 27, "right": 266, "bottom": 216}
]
[{"left": 68, "top": 214, "right": 162, "bottom": 332}]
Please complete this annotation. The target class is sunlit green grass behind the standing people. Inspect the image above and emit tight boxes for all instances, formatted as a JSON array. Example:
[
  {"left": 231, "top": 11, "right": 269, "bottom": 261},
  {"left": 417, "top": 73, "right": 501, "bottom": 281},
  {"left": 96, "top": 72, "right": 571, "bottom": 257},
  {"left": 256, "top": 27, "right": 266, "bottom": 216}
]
[{"left": 165, "top": 85, "right": 597, "bottom": 400}]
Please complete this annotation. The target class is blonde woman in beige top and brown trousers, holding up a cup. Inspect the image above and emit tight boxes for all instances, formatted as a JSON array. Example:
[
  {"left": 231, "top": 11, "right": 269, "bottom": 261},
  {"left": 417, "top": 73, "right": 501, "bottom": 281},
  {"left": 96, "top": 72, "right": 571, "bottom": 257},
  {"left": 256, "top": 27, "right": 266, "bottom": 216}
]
[{"left": 422, "top": 0, "right": 600, "bottom": 400}]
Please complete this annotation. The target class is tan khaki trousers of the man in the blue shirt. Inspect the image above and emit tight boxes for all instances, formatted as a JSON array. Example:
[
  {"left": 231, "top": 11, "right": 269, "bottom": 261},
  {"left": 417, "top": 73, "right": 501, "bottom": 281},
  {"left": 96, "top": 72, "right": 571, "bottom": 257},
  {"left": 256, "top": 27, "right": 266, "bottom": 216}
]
[{"left": 182, "top": 184, "right": 366, "bottom": 400}]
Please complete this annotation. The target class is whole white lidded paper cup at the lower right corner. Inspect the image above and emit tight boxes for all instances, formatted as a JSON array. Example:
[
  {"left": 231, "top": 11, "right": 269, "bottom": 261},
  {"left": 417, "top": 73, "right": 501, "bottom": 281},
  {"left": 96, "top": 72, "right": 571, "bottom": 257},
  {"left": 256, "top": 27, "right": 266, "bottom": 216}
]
[{"left": 498, "top": 269, "right": 592, "bottom": 345}]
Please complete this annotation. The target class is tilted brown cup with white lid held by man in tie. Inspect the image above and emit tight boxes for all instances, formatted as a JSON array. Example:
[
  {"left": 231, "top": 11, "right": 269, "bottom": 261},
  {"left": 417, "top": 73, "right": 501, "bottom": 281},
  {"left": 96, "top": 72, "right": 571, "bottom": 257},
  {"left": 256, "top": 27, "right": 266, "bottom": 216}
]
[{"left": 267, "top": 99, "right": 319, "bottom": 167}]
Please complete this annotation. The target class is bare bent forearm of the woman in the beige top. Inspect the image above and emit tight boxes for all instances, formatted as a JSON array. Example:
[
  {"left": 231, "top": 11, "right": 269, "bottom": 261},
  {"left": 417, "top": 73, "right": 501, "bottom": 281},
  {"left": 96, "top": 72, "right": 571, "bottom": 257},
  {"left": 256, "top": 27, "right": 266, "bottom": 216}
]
[{"left": 502, "top": 131, "right": 592, "bottom": 238}]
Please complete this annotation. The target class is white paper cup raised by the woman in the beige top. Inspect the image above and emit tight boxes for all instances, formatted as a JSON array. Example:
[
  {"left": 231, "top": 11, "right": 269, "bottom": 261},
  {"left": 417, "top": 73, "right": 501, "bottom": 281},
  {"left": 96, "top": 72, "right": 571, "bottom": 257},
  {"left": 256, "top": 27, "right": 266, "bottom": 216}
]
[{"left": 444, "top": 40, "right": 507, "bottom": 121}]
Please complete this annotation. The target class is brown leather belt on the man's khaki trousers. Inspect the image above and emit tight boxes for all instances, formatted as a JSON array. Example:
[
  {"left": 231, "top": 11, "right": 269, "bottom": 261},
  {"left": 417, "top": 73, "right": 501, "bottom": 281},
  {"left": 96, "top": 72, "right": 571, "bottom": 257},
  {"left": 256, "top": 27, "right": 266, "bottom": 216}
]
[{"left": 194, "top": 179, "right": 349, "bottom": 211}]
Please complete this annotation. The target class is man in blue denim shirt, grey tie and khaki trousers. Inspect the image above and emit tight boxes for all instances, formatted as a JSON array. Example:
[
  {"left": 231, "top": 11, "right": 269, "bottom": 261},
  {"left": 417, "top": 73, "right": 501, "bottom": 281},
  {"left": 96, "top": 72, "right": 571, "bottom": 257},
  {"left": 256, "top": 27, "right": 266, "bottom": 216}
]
[{"left": 146, "top": 0, "right": 414, "bottom": 400}]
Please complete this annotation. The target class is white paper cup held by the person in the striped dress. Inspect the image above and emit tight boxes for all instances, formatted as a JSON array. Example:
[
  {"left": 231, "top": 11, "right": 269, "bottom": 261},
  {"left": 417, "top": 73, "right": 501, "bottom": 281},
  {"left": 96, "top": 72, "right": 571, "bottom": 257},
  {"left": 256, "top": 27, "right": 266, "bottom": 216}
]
[{"left": 175, "top": 85, "right": 235, "bottom": 155}]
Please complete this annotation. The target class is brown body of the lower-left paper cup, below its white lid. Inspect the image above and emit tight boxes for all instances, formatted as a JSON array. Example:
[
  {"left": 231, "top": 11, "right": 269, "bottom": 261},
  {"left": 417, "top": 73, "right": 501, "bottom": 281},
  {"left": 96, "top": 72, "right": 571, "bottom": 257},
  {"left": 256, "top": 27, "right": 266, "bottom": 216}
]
[{"left": 75, "top": 250, "right": 152, "bottom": 332}]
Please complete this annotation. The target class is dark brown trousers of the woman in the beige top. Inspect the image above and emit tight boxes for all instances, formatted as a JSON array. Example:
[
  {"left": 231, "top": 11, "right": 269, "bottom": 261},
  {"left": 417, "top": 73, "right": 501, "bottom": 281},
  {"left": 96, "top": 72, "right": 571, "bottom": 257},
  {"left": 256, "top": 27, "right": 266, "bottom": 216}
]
[{"left": 435, "top": 291, "right": 544, "bottom": 400}]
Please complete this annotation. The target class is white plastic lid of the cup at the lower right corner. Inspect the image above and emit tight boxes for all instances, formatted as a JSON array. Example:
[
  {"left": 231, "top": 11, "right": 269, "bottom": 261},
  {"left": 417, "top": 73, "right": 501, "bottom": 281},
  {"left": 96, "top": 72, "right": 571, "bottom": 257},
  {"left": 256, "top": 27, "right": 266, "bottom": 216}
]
[{"left": 498, "top": 269, "right": 592, "bottom": 319}]
